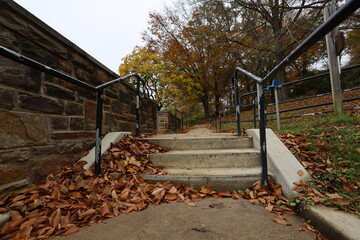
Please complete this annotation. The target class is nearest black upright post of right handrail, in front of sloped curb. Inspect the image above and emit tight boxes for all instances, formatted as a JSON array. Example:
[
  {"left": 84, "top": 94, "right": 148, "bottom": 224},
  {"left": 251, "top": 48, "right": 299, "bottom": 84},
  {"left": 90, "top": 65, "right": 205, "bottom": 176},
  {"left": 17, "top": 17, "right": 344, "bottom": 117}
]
[{"left": 257, "top": 83, "right": 268, "bottom": 186}]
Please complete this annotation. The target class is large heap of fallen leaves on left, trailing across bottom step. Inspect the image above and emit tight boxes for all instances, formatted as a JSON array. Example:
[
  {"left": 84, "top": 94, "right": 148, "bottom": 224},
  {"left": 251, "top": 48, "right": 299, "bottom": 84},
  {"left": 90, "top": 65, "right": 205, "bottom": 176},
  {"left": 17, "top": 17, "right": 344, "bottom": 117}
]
[{"left": 0, "top": 137, "right": 316, "bottom": 239}]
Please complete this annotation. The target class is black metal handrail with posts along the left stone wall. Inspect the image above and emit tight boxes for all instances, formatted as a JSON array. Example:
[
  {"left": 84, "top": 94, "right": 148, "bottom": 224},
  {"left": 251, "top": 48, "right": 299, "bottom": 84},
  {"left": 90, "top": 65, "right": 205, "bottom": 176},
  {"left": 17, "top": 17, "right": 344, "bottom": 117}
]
[{"left": 0, "top": 45, "right": 155, "bottom": 174}]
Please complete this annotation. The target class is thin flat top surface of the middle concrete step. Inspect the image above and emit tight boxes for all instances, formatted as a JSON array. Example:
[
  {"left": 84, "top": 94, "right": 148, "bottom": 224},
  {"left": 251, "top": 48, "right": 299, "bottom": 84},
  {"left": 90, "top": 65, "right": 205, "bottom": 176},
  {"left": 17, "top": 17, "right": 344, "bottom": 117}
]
[{"left": 149, "top": 148, "right": 260, "bottom": 155}]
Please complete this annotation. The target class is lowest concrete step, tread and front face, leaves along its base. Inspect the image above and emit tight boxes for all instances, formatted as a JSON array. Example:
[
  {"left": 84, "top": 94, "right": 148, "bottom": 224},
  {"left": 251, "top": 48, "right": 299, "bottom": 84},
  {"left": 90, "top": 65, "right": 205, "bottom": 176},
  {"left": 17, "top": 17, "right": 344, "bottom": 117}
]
[{"left": 141, "top": 168, "right": 268, "bottom": 191}]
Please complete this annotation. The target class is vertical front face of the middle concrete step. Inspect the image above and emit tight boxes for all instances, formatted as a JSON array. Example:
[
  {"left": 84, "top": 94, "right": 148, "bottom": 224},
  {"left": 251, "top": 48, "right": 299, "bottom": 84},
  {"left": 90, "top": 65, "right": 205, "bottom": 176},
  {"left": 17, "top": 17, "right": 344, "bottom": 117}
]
[{"left": 149, "top": 152, "right": 261, "bottom": 168}]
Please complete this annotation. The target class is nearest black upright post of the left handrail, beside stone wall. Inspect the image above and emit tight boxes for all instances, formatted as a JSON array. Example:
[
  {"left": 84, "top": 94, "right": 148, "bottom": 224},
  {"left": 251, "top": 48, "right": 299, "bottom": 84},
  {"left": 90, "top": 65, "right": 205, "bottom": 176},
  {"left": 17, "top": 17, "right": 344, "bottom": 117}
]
[{"left": 95, "top": 89, "right": 104, "bottom": 175}]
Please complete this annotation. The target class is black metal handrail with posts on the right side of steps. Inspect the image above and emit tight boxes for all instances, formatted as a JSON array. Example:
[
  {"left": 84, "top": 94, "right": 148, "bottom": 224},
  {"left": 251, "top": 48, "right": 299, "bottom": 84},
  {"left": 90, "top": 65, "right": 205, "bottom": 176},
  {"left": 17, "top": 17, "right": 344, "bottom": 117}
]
[{"left": 232, "top": 0, "right": 360, "bottom": 185}]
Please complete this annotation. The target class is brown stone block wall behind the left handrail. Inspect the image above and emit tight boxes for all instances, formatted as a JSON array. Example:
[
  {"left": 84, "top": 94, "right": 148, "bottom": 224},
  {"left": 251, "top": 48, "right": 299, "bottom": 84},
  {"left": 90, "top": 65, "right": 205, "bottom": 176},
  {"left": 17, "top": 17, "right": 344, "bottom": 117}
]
[{"left": 0, "top": 0, "right": 157, "bottom": 194}]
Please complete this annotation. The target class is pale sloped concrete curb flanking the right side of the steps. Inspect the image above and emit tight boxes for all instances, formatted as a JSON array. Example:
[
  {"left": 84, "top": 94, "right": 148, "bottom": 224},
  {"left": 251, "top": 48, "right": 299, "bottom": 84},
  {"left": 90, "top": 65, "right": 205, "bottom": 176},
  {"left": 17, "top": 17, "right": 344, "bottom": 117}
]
[{"left": 246, "top": 129, "right": 311, "bottom": 200}]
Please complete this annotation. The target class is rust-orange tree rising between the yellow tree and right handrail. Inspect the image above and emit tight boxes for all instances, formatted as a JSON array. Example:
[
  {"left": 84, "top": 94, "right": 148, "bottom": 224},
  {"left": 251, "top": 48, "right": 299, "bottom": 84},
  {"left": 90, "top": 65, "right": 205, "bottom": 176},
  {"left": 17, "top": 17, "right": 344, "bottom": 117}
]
[{"left": 144, "top": 0, "right": 235, "bottom": 118}]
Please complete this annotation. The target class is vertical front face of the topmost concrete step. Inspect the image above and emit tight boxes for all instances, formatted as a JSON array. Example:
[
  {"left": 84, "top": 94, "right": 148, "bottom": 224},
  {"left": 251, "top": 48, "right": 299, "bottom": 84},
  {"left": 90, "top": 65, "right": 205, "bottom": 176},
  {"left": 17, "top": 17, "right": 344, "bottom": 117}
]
[{"left": 139, "top": 137, "right": 253, "bottom": 150}]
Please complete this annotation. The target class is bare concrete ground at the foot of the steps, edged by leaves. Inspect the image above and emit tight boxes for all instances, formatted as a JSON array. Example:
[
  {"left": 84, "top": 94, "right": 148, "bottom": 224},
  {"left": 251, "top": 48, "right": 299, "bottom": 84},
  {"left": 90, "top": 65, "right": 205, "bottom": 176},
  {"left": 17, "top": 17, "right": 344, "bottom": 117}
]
[{"left": 58, "top": 198, "right": 315, "bottom": 240}]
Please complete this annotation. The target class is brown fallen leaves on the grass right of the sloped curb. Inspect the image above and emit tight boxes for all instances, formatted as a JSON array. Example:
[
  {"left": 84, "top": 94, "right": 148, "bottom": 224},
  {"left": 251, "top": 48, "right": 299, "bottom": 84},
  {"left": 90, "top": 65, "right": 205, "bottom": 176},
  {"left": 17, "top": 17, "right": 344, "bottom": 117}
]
[{"left": 278, "top": 133, "right": 360, "bottom": 213}]
